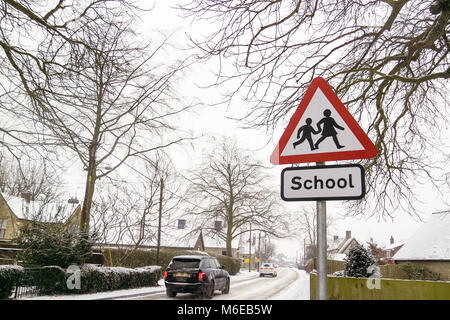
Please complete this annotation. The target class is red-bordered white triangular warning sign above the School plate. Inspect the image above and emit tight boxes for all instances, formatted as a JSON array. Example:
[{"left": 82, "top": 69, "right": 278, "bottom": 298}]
[{"left": 270, "top": 78, "right": 378, "bottom": 164}]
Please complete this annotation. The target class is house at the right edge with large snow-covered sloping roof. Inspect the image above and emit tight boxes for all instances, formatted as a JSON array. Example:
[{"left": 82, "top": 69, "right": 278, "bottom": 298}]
[{"left": 393, "top": 211, "right": 450, "bottom": 281}]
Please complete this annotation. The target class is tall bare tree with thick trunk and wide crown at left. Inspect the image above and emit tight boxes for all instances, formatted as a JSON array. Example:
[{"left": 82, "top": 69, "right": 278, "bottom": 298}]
[{"left": 0, "top": 0, "right": 194, "bottom": 230}]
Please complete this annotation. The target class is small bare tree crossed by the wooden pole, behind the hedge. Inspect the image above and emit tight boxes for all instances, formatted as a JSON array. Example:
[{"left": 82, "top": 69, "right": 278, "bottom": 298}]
[{"left": 92, "top": 153, "right": 185, "bottom": 265}]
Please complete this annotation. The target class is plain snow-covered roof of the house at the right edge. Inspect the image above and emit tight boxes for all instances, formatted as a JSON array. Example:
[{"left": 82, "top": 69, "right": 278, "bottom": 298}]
[{"left": 393, "top": 211, "right": 450, "bottom": 261}]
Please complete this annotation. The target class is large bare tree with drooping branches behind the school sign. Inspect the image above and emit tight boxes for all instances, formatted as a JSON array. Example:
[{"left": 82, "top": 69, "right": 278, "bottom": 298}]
[{"left": 179, "top": 0, "right": 450, "bottom": 216}]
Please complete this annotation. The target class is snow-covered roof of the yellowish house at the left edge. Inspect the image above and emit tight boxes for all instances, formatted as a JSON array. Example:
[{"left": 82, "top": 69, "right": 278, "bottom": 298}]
[{"left": 2, "top": 193, "right": 76, "bottom": 221}]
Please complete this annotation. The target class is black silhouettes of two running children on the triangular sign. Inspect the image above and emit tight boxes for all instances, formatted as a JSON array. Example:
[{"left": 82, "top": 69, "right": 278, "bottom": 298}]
[{"left": 293, "top": 109, "right": 345, "bottom": 151}]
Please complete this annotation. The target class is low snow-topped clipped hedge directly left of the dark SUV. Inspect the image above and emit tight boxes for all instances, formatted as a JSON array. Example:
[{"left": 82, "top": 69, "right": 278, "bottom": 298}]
[{"left": 80, "top": 264, "right": 162, "bottom": 293}]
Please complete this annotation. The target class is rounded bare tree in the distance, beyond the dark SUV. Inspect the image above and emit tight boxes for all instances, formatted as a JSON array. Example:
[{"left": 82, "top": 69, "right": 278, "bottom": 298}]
[{"left": 186, "top": 139, "right": 287, "bottom": 257}]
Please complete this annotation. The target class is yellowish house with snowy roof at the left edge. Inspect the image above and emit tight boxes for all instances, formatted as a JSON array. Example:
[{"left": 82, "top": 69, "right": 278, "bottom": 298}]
[{"left": 0, "top": 192, "right": 81, "bottom": 264}]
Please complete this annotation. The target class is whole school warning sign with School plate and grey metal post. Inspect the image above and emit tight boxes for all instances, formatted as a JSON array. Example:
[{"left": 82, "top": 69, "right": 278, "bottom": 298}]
[{"left": 270, "top": 77, "right": 378, "bottom": 300}]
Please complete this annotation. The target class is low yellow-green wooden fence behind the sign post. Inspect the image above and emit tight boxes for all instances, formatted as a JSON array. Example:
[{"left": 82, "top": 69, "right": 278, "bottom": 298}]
[{"left": 310, "top": 274, "right": 450, "bottom": 300}]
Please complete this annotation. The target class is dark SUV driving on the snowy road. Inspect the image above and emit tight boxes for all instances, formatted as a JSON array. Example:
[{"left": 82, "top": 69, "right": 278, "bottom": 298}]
[{"left": 164, "top": 255, "right": 230, "bottom": 299}]
